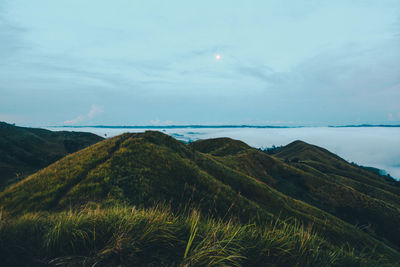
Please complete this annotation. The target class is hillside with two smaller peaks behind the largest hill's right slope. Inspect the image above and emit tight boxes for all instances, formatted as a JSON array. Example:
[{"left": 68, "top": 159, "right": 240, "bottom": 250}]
[{"left": 190, "top": 139, "right": 400, "bottom": 250}]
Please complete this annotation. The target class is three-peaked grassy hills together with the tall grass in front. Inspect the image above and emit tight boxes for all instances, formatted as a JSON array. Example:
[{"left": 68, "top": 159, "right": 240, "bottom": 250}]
[{"left": 0, "top": 131, "right": 400, "bottom": 266}]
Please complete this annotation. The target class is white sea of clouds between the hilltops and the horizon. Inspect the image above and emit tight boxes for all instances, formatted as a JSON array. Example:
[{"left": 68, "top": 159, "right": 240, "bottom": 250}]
[{"left": 47, "top": 127, "right": 400, "bottom": 179}]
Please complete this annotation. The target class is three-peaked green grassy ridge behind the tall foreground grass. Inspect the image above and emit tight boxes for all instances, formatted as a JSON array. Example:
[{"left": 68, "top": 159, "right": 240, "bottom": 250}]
[{"left": 0, "top": 131, "right": 400, "bottom": 266}]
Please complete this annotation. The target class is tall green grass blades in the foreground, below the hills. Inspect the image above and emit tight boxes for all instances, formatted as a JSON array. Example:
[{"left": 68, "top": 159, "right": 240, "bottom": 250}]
[{"left": 0, "top": 207, "right": 385, "bottom": 266}]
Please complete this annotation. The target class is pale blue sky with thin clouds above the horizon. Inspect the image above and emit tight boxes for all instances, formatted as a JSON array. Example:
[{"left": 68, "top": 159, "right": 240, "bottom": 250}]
[{"left": 0, "top": 0, "right": 400, "bottom": 126}]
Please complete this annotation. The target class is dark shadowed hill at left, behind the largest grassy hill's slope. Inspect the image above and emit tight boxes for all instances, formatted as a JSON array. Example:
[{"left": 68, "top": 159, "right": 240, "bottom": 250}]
[{"left": 0, "top": 122, "right": 103, "bottom": 189}]
